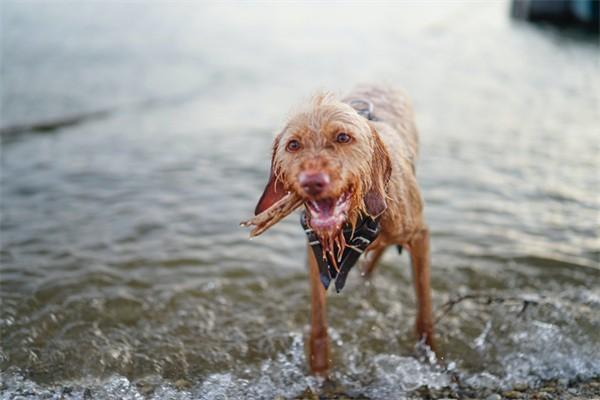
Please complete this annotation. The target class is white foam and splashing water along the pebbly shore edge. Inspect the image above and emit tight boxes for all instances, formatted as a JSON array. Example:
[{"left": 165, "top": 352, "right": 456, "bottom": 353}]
[{"left": 1, "top": 304, "right": 600, "bottom": 400}]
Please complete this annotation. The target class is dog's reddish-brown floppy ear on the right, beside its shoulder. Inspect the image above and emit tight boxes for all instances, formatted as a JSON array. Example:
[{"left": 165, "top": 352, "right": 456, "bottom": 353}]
[{"left": 363, "top": 128, "right": 392, "bottom": 218}]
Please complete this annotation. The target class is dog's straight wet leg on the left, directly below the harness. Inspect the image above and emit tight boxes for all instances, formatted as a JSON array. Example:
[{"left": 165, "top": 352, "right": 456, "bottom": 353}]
[{"left": 307, "top": 246, "right": 329, "bottom": 376}]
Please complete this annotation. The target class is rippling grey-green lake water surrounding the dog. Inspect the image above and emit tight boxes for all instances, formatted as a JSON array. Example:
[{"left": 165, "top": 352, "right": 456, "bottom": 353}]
[{"left": 0, "top": 2, "right": 600, "bottom": 399}]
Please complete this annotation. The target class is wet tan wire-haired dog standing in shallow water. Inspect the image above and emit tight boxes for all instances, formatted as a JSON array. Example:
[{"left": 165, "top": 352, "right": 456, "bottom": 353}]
[{"left": 248, "top": 86, "right": 434, "bottom": 376}]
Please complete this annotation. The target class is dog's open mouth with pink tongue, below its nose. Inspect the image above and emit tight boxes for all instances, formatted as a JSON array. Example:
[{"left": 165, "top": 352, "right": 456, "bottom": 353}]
[{"left": 305, "top": 190, "right": 352, "bottom": 236}]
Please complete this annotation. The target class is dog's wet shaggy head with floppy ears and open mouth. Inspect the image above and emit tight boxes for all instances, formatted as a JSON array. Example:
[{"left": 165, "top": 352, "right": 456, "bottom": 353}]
[{"left": 255, "top": 94, "right": 391, "bottom": 244}]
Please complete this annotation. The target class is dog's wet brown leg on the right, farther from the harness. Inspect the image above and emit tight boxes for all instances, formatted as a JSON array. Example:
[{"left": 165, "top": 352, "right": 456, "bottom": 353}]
[{"left": 408, "top": 227, "right": 435, "bottom": 351}]
